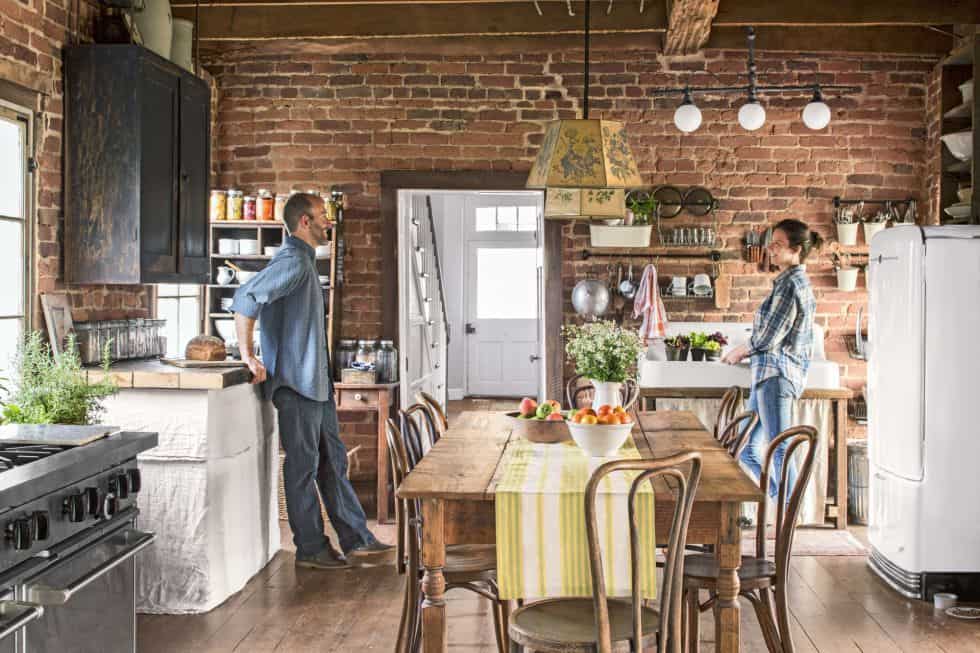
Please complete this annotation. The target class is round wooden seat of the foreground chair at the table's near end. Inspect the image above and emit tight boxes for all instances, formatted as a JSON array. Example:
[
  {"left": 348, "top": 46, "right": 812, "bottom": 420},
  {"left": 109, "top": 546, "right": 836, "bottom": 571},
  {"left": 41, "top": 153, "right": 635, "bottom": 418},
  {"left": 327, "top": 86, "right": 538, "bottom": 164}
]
[{"left": 510, "top": 597, "right": 660, "bottom": 653}]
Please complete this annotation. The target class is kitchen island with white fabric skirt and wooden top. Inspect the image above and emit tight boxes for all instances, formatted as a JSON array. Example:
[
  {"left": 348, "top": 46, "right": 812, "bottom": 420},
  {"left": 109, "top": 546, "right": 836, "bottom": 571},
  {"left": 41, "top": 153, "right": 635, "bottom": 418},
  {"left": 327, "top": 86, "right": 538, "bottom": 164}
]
[{"left": 89, "top": 361, "right": 279, "bottom": 614}]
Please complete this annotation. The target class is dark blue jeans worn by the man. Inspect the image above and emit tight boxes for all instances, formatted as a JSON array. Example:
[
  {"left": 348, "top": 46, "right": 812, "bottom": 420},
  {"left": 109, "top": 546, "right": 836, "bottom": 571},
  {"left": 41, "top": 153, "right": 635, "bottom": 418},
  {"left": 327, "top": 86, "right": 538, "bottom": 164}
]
[{"left": 272, "top": 387, "right": 374, "bottom": 557}]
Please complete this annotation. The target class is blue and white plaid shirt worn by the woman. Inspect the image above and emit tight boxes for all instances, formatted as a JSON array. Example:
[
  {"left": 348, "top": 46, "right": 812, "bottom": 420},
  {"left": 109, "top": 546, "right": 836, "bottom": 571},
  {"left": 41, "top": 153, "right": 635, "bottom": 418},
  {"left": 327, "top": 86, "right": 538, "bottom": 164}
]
[{"left": 749, "top": 265, "right": 817, "bottom": 398}]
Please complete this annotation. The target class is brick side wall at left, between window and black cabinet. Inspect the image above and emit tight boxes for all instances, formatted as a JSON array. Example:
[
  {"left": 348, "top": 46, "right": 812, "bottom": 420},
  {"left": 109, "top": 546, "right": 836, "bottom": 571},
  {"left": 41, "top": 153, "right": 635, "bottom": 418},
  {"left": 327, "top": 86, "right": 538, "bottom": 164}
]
[{"left": 0, "top": 0, "right": 149, "bottom": 329}]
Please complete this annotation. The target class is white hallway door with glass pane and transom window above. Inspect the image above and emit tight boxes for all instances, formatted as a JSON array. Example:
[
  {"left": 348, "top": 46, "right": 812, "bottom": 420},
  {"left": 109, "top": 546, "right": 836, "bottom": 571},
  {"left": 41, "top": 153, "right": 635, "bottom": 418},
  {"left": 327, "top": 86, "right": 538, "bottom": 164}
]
[{"left": 464, "top": 195, "right": 541, "bottom": 397}]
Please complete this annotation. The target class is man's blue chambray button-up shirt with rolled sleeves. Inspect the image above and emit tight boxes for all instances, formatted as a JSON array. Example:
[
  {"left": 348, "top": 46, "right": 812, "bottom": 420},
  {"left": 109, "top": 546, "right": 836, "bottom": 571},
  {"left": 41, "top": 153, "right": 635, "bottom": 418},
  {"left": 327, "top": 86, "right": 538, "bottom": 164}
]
[{"left": 231, "top": 236, "right": 333, "bottom": 401}]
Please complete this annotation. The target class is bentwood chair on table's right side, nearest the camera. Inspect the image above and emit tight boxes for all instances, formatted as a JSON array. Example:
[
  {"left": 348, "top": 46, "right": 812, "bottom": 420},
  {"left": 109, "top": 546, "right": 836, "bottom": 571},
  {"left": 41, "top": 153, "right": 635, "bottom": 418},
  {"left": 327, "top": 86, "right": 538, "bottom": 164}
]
[{"left": 684, "top": 426, "right": 817, "bottom": 653}]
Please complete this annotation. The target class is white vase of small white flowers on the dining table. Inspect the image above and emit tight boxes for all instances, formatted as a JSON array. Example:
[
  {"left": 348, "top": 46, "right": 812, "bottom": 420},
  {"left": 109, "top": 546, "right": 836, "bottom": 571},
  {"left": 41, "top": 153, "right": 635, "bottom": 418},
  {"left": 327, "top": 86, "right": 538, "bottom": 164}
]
[{"left": 562, "top": 321, "right": 645, "bottom": 406}]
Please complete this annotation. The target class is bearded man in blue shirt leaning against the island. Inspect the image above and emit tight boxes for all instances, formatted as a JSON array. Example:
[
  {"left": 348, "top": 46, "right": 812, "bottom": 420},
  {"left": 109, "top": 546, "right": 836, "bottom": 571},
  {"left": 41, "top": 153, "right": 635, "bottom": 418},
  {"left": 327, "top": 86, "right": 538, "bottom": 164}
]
[{"left": 232, "top": 193, "right": 393, "bottom": 569}]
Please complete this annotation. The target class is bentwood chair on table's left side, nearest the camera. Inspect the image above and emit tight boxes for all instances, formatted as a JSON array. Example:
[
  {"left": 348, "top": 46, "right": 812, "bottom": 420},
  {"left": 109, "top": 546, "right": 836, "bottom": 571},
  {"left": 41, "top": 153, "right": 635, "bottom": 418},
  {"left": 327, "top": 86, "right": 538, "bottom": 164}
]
[{"left": 385, "top": 406, "right": 510, "bottom": 653}]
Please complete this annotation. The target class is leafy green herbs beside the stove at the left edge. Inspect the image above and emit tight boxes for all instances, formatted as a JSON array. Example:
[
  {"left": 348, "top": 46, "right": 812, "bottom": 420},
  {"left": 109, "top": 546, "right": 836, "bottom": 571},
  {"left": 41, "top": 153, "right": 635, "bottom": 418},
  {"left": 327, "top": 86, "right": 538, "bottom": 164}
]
[{"left": 0, "top": 331, "right": 116, "bottom": 424}]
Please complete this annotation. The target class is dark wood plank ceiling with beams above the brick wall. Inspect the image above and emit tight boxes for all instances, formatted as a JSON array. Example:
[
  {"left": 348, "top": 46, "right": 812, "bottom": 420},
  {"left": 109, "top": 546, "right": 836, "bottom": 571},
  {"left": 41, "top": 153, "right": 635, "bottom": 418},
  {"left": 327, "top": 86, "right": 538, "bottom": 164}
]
[{"left": 172, "top": 0, "right": 980, "bottom": 55}]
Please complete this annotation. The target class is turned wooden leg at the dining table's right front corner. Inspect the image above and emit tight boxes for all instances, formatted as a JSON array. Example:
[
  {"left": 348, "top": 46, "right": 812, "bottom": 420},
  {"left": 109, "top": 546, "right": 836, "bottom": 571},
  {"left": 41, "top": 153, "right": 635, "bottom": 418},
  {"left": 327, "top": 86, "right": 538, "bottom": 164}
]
[{"left": 714, "top": 501, "right": 744, "bottom": 653}]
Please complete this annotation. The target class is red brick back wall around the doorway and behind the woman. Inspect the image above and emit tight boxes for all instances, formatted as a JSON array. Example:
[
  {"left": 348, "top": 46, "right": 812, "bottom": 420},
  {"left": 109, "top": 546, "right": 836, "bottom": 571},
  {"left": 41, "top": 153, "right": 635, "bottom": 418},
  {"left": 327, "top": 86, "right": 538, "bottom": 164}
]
[{"left": 206, "top": 50, "right": 935, "bottom": 402}]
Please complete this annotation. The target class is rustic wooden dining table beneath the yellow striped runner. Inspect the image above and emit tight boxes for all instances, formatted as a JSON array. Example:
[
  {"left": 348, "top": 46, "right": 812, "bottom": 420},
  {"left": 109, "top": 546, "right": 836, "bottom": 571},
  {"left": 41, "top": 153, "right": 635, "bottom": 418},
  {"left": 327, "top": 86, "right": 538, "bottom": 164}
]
[{"left": 398, "top": 411, "right": 762, "bottom": 653}]
